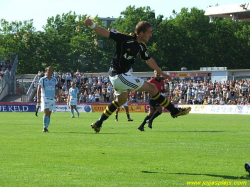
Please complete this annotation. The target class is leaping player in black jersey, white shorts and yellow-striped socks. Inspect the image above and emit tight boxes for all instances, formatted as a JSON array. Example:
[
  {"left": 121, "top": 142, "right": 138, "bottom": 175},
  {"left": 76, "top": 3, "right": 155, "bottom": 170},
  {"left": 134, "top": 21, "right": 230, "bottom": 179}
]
[{"left": 84, "top": 18, "right": 191, "bottom": 132}]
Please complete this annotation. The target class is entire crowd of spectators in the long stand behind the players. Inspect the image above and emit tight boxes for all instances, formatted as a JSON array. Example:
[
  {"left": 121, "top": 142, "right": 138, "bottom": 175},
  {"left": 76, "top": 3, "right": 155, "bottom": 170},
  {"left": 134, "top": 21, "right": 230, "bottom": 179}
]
[{"left": 35, "top": 70, "right": 250, "bottom": 105}]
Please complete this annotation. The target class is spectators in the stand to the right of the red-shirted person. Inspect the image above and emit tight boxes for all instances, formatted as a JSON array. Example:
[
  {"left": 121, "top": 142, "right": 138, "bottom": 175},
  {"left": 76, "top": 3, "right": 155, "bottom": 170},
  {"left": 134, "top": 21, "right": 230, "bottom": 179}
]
[{"left": 168, "top": 79, "right": 250, "bottom": 105}]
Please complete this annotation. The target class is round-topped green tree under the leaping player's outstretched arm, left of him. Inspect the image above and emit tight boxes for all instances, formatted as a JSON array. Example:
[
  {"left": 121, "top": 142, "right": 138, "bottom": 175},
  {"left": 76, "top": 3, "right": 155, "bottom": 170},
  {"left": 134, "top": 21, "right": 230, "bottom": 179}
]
[{"left": 40, "top": 12, "right": 107, "bottom": 72}]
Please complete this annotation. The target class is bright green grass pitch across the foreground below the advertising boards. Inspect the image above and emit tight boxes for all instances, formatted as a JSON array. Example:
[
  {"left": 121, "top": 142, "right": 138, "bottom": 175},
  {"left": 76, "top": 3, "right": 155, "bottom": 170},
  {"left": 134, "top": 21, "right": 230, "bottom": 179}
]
[{"left": 0, "top": 113, "right": 250, "bottom": 187}]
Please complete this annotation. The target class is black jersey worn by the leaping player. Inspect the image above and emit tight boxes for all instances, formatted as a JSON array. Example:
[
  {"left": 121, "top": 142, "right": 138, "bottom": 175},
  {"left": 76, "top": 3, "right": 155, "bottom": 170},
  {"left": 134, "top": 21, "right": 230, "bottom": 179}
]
[{"left": 109, "top": 31, "right": 150, "bottom": 74}]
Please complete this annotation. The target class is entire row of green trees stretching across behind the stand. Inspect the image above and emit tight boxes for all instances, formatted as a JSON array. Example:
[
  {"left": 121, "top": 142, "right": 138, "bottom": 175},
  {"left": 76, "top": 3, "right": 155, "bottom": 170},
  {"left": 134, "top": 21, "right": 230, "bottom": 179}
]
[{"left": 0, "top": 6, "right": 250, "bottom": 73}]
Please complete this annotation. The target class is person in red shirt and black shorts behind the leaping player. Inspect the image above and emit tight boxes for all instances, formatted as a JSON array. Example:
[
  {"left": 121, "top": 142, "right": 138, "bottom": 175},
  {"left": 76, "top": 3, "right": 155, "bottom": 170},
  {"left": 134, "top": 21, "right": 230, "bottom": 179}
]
[{"left": 138, "top": 70, "right": 167, "bottom": 131}]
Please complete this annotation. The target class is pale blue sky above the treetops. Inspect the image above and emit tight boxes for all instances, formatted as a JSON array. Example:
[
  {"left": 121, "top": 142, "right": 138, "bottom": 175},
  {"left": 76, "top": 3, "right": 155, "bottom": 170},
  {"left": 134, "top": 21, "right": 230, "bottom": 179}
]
[{"left": 0, "top": 0, "right": 247, "bottom": 30}]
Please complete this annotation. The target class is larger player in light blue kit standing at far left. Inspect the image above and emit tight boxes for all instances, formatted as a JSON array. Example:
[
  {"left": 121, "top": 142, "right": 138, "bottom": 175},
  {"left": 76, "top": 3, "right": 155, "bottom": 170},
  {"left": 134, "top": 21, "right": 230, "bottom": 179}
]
[{"left": 37, "top": 66, "right": 61, "bottom": 132}]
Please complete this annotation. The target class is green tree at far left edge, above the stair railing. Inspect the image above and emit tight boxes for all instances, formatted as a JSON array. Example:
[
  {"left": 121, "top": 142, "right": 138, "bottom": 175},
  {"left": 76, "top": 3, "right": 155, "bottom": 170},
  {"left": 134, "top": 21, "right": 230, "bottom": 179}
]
[{"left": 1, "top": 19, "right": 40, "bottom": 73}]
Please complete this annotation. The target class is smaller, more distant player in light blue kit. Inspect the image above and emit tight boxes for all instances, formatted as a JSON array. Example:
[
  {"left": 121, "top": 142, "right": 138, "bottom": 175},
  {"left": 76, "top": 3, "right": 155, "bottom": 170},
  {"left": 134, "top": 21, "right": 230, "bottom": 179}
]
[{"left": 68, "top": 81, "right": 79, "bottom": 118}]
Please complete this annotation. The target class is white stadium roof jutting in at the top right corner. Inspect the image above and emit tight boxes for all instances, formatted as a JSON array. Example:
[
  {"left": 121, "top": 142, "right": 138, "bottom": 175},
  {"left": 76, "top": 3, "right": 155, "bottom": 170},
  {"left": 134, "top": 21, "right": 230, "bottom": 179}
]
[{"left": 205, "top": 3, "right": 250, "bottom": 22}]
